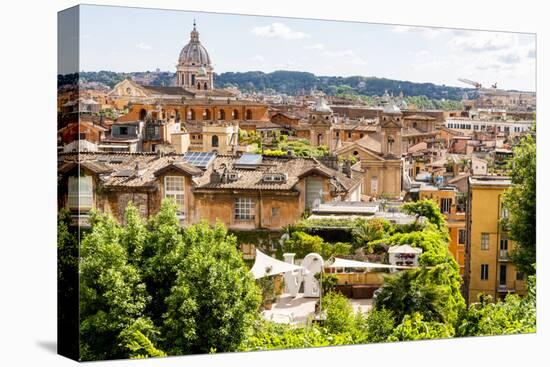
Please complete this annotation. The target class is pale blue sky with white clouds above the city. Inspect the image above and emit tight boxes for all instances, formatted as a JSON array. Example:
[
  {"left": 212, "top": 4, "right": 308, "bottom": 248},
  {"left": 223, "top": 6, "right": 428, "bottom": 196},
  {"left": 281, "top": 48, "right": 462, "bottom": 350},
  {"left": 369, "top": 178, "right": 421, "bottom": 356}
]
[{"left": 80, "top": 5, "right": 535, "bottom": 91}]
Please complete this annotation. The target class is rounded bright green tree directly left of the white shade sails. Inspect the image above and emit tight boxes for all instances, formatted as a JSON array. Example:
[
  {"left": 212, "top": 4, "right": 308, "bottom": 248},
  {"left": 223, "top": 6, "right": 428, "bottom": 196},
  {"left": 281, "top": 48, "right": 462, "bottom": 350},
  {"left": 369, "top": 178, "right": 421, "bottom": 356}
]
[{"left": 162, "top": 223, "right": 261, "bottom": 354}]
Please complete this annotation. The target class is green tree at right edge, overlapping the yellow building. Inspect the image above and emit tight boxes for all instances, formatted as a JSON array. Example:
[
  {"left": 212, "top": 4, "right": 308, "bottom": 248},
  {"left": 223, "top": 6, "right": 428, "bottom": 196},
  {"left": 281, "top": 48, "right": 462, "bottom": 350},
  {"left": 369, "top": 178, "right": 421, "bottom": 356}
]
[{"left": 503, "top": 125, "right": 537, "bottom": 274}]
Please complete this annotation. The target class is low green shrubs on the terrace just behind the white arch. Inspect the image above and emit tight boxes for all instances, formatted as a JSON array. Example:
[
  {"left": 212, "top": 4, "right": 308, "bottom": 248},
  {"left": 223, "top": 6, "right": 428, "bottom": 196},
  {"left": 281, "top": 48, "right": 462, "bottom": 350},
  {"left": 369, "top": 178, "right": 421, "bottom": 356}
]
[{"left": 284, "top": 231, "right": 351, "bottom": 259}]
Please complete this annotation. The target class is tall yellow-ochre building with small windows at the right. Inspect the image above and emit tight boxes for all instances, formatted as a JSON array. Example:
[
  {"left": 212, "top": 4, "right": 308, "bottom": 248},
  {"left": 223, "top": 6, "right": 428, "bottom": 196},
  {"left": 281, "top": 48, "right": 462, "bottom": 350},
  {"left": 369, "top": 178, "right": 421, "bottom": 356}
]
[{"left": 464, "top": 176, "right": 526, "bottom": 303}]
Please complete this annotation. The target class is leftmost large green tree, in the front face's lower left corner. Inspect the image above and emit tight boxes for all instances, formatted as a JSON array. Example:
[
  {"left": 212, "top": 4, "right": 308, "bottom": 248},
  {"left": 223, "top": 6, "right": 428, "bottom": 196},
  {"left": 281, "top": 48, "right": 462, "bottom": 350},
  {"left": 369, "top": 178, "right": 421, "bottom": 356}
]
[{"left": 80, "top": 208, "right": 153, "bottom": 360}]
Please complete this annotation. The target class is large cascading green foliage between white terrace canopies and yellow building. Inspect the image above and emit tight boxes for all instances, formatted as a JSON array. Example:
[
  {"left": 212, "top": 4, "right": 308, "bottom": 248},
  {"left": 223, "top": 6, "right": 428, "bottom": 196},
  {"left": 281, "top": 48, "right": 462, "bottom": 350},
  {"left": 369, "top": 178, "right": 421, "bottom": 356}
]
[{"left": 375, "top": 200, "right": 465, "bottom": 323}]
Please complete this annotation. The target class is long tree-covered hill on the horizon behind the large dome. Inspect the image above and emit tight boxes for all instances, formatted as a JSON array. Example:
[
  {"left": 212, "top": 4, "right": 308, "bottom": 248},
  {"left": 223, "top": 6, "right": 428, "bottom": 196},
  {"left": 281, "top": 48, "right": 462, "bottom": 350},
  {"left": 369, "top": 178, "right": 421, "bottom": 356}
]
[{"left": 68, "top": 70, "right": 476, "bottom": 101}]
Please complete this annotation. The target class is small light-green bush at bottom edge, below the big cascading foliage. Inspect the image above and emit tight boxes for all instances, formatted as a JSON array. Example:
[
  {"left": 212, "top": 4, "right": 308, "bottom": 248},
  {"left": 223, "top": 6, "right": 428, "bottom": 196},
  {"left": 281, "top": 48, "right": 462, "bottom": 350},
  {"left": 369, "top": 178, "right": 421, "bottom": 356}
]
[{"left": 388, "top": 312, "right": 454, "bottom": 341}]
